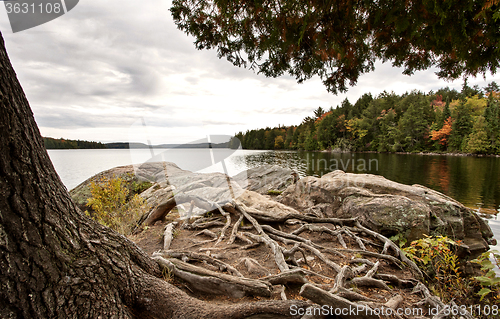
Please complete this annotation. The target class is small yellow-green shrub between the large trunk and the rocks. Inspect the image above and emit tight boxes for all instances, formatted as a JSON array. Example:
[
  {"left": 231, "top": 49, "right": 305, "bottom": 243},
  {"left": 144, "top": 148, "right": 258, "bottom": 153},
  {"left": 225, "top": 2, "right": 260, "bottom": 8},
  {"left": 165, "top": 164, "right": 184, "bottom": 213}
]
[{"left": 87, "top": 177, "right": 146, "bottom": 235}]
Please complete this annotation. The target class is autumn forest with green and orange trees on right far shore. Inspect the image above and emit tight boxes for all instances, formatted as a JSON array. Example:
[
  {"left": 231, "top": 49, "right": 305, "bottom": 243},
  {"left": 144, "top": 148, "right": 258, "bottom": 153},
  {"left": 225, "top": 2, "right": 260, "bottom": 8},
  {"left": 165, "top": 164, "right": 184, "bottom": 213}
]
[{"left": 235, "top": 81, "right": 500, "bottom": 154}]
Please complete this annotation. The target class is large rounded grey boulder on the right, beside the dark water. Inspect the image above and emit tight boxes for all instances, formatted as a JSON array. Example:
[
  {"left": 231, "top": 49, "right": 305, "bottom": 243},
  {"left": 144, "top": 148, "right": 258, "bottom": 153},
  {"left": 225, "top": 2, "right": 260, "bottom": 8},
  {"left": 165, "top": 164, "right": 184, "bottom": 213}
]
[{"left": 277, "top": 170, "right": 495, "bottom": 256}]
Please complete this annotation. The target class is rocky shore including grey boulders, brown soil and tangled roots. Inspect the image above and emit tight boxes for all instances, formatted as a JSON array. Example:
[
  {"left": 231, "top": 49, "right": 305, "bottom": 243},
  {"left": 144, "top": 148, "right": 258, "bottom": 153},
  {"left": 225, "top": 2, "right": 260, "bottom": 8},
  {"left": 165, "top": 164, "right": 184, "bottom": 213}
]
[{"left": 70, "top": 162, "right": 495, "bottom": 318}]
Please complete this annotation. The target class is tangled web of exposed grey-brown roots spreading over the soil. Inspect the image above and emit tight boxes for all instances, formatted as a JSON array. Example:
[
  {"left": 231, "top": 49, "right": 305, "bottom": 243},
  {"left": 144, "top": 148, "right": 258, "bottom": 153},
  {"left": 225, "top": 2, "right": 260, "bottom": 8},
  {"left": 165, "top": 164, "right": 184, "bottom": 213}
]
[{"left": 133, "top": 196, "right": 458, "bottom": 318}]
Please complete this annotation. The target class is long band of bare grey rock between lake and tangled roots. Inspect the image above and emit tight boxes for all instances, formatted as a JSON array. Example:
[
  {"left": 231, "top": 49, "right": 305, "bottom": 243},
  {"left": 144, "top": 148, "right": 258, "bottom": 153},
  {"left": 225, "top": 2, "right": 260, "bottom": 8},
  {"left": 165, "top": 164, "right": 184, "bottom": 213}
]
[{"left": 70, "top": 162, "right": 495, "bottom": 255}]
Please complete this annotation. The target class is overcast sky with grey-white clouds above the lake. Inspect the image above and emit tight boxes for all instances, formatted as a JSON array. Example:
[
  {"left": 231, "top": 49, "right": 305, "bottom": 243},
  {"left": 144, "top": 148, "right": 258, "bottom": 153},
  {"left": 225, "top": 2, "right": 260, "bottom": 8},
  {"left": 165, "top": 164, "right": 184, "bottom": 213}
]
[{"left": 0, "top": 0, "right": 500, "bottom": 144}]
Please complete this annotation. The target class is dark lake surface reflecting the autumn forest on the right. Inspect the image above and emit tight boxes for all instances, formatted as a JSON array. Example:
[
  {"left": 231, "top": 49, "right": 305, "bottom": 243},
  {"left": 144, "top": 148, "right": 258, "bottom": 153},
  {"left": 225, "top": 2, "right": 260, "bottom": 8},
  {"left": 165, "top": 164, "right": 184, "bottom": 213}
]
[{"left": 233, "top": 151, "right": 500, "bottom": 212}]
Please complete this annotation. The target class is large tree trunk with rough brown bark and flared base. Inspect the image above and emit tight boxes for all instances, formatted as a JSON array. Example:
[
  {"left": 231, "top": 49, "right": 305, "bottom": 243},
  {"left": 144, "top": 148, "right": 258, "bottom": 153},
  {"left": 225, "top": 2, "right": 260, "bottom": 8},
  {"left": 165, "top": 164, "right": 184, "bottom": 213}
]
[{"left": 0, "top": 36, "right": 304, "bottom": 318}]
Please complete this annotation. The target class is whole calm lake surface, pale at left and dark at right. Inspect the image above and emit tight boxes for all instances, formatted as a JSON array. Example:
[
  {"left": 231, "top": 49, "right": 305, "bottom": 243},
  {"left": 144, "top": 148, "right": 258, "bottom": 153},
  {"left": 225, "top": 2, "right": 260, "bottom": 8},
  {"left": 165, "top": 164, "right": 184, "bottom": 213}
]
[{"left": 49, "top": 149, "right": 500, "bottom": 249}]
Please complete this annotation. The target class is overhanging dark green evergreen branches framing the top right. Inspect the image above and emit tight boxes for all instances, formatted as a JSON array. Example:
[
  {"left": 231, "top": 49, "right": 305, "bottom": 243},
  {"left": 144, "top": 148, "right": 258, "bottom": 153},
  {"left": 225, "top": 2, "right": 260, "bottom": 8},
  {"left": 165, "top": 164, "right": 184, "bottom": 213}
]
[{"left": 171, "top": 0, "right": 500, "bottom": 94}]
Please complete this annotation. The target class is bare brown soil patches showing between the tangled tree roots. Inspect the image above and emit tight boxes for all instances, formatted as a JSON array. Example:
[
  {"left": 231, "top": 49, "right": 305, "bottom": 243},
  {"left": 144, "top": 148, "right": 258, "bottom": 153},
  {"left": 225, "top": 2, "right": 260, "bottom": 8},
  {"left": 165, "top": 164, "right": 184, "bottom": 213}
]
[{"left": 129, "top": 211, "right": 425, "bottom": 315}]
